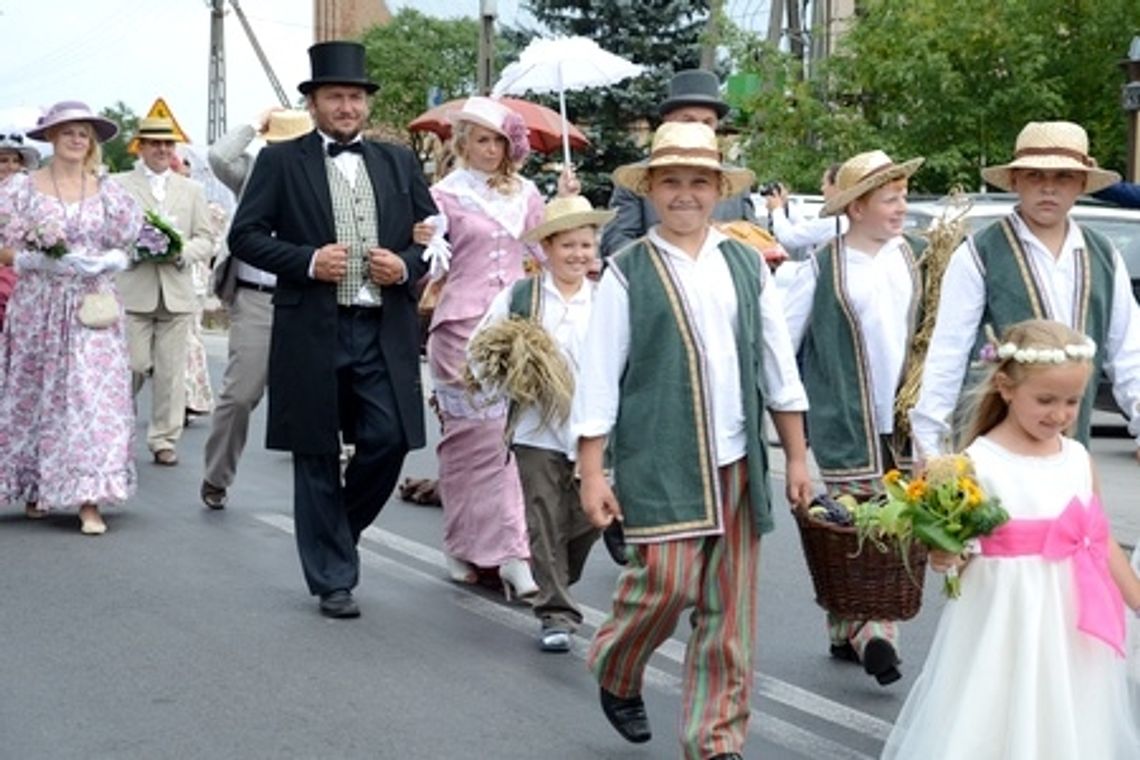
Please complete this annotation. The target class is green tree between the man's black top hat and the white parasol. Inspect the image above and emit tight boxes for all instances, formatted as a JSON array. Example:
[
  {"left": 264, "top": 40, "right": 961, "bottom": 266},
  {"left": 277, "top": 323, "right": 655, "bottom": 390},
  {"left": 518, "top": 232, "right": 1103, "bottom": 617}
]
[{"left": 363, "top": 8, "right": 479, "bottom": 158}]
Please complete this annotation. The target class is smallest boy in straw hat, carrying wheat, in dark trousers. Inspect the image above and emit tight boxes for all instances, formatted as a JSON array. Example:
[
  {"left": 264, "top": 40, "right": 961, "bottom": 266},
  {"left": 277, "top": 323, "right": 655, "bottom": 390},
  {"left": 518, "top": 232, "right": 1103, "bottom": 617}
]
[{"left": 467, "top": 196, "right": 614, "bottom": 652}]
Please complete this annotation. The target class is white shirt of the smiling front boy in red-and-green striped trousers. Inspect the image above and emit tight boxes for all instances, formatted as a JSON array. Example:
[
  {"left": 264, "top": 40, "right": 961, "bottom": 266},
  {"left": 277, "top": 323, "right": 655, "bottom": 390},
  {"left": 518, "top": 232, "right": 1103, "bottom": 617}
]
[{"left": 571, "top": 227, "right": 807, "bottom": 466}]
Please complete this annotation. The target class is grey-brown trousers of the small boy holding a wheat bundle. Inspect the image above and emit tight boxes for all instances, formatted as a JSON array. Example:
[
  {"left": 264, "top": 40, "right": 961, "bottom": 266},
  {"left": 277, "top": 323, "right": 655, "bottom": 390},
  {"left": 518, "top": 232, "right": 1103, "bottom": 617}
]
[{"left": 514, "top": 446, "right": 601, "bottom": 631}]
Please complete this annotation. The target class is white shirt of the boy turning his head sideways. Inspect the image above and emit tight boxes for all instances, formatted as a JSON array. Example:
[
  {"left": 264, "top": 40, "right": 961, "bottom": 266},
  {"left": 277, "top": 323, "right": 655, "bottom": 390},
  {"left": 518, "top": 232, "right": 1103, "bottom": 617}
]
[{"left": 783, "top": 237, "right": 914, "bottom": 434}]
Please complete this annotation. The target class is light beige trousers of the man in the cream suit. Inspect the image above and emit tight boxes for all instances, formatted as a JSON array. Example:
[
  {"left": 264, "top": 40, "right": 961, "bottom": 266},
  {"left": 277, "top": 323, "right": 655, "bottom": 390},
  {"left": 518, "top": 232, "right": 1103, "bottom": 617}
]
[{"left": 127, "top": 293, "right": 195, "bottom": 451}]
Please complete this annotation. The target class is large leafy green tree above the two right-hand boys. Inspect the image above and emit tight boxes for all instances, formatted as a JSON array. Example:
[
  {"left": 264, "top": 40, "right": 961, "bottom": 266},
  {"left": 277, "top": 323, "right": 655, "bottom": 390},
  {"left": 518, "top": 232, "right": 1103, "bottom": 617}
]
[{"left": 733, "top": 0, "right": 1140, "bottom": 193}]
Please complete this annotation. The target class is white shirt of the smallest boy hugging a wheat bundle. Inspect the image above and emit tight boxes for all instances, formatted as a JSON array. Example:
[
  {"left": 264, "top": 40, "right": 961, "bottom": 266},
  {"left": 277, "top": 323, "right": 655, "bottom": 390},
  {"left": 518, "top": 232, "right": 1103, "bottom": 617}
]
[{"left": 467, "top": 271, "right": 595, "bottom": 459}]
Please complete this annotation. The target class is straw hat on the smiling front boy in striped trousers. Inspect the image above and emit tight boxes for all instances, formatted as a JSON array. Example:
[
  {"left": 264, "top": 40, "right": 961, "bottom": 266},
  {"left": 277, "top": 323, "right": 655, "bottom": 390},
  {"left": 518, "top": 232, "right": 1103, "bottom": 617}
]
[{"left": 613, "top": 122, "right": 756, "bottom": 197}]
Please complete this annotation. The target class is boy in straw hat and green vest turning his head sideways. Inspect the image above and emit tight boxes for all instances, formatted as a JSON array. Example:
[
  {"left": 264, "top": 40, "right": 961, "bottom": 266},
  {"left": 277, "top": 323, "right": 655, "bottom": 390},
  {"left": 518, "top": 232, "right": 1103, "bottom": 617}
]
[{"left": 783, "top": 150, "right": 926, "bottom": 685}]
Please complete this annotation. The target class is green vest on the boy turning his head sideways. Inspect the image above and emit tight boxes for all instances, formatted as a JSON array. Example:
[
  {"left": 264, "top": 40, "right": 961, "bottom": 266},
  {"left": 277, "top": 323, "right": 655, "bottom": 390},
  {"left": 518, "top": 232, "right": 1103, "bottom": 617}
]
[{"left": 804, "top": 235, "right": 927, "bottom": 482}]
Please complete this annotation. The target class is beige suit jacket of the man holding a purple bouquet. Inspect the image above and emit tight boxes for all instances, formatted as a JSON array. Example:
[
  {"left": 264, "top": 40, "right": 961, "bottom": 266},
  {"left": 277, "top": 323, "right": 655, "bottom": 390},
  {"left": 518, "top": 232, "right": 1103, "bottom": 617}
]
[{"left": 112, "top": 162, "right": 214, "bottom": 313}]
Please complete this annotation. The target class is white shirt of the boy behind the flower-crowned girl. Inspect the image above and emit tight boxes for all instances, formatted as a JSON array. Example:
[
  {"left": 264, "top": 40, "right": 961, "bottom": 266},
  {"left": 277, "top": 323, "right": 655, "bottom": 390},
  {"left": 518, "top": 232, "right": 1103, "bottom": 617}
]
[{"left": 911, "top": 213, "right": 1140, "bottom": 456}]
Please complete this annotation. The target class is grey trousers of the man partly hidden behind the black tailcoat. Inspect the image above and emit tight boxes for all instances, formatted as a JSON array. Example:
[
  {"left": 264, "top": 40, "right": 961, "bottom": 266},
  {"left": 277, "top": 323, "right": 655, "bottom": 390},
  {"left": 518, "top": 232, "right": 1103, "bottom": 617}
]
[{"left": 203, "top": 287, "right": 274, "bottom": 488}]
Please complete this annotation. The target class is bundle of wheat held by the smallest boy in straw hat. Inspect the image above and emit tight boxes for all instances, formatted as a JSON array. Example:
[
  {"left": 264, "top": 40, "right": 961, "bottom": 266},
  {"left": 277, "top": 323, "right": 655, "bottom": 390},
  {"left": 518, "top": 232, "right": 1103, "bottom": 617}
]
[{"left": 464, "top": 317, "right": 573, "bottom": 440}]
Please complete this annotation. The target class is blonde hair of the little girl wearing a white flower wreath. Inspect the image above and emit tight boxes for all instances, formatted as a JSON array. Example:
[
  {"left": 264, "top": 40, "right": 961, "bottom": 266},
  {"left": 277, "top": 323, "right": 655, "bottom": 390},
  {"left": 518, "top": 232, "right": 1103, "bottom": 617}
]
[{"left": 962, "top": 319, "right": 1092, "bottom": 448}]
